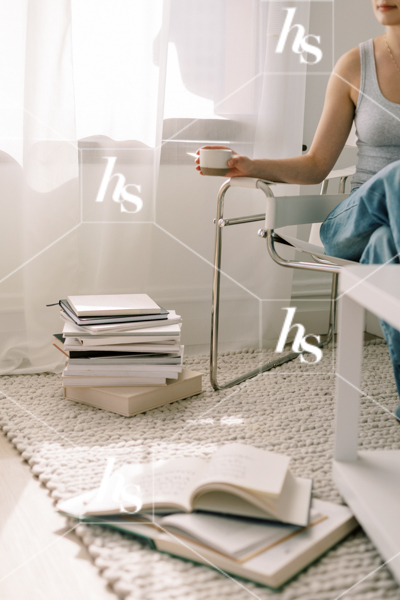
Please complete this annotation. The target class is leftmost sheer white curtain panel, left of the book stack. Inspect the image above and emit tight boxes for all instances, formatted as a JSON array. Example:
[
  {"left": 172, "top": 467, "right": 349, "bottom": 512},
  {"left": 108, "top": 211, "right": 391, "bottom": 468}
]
[{"left": 0, "top": 0, "right": 80, "bottom": 373}]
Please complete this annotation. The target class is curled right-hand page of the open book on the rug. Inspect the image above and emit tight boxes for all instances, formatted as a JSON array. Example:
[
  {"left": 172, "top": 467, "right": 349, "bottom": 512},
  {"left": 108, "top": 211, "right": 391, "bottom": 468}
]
[{"left": 197, "top": 444, "right": 290, "bottom": 496}]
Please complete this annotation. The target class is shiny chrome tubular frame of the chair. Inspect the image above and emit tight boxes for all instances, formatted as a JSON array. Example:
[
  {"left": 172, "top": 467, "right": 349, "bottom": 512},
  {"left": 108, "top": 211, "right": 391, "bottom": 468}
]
[{"left": 210, "top": 172, "right": 354, "bottom": 390}]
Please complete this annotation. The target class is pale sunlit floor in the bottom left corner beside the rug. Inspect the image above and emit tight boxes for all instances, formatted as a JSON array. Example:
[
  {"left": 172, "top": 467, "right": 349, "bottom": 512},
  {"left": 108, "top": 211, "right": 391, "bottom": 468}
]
[{"left": 0, "top": 432, "right": 116, "bottom": 600}]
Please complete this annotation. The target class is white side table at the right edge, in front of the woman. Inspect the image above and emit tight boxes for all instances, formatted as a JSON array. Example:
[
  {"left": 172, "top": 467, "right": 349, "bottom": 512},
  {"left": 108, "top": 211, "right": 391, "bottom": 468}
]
[{"left": 333, "top": 265, "right": 400, "bottom": 583}]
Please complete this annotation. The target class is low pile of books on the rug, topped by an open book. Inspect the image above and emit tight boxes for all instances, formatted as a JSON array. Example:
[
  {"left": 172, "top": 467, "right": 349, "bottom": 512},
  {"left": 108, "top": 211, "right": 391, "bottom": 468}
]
[{"left": 58, "top": 444, "right": 357, "bottom": 588}]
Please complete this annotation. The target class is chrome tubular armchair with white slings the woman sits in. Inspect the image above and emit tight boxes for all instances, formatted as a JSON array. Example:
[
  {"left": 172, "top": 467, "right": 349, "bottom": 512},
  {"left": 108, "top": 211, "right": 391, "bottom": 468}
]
[{"left": 210, "top": 130, "right": 355, "bottom": 390}]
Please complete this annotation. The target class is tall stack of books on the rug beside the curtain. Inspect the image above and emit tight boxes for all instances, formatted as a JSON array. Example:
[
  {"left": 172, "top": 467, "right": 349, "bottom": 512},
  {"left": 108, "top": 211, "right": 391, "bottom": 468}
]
[{"left": 54, "top": 294, "right": 201, "bottom": 415}]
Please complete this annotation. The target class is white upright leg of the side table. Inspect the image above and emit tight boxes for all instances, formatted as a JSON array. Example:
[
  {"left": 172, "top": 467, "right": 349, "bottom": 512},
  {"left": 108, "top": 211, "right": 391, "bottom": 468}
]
[{"left": 334, "top": 294, "right": 364, "bottom": 461}]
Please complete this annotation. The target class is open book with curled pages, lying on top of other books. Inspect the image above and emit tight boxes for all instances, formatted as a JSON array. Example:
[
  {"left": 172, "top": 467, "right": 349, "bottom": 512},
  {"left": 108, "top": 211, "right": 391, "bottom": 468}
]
[{"left": 57, "top": 444, "right": 312, "bottom": 526}]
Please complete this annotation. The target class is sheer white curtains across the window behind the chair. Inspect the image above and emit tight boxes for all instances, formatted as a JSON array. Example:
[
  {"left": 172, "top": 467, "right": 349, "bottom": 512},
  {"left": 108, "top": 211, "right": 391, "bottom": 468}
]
[{"left": 0, "top": 0, "right": 309, "bottom": 373}]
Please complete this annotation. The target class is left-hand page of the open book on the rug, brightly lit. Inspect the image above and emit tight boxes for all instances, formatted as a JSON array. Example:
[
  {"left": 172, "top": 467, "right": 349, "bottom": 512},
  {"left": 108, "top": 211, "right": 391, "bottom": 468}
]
[{"left": 79, "top": 458, "right": 206, "bottom": 515}]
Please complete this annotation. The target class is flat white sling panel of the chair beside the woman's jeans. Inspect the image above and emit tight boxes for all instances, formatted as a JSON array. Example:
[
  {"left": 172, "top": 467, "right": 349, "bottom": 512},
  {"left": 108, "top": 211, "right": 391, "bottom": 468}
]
[{"left": 265, "top": 194, "right": 348, "bottom": 229}]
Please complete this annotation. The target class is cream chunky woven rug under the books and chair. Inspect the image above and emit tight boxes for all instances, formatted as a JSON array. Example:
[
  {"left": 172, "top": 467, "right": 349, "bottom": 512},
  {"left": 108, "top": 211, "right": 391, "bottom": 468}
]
[{"left": 0, "top": 341, "right": 400, "bottom": 600}]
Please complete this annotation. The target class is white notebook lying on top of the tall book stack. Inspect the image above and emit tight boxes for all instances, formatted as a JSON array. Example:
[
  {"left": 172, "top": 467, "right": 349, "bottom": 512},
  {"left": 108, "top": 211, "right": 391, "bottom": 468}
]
[{"left": 68, "top": 294, "right": 161, "bottom": 317}]
